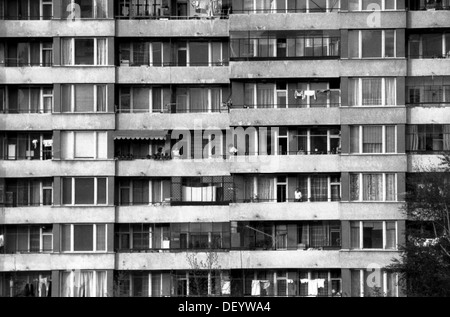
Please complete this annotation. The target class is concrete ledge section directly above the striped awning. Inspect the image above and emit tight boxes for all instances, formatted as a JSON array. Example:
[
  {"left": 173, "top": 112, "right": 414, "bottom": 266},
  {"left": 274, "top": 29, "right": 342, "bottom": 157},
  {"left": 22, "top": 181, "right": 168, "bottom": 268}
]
[{"left": 117, "top": 111, "right": 230, "bottom": 130}]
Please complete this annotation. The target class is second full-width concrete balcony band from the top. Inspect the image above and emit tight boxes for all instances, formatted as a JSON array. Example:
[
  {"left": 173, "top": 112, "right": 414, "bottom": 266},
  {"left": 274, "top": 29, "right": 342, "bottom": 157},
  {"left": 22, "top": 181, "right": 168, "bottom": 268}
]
[{"left": 0, "top": 58, "right": 450, "bottom": 85}]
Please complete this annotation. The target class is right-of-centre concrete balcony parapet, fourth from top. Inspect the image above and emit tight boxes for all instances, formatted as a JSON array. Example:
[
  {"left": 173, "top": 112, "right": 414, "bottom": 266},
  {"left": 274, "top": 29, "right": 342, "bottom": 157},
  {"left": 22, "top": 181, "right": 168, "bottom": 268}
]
[{"left": 229, "top": 154, "right": 341, "bottom": 174}]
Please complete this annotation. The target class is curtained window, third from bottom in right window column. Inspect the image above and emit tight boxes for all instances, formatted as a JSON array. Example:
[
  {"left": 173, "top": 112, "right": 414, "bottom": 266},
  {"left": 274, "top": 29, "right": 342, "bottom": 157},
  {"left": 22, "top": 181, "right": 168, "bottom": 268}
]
[{"left": 350, "top": 174, "right": 397, "bottom": 202}]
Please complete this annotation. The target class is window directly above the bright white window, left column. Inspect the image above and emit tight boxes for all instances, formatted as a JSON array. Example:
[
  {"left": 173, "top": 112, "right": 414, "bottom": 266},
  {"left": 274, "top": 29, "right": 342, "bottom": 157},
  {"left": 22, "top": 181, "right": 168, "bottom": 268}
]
[{"left": 61, "top": 84, "right": 107, "bottom": 113}]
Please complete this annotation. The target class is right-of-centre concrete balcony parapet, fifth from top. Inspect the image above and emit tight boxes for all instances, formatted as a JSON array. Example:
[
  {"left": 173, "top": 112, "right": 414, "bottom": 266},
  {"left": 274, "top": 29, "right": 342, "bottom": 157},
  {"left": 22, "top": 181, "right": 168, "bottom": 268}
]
[{"left": 229, "top": 201, "right": 339, "bottom": 221}]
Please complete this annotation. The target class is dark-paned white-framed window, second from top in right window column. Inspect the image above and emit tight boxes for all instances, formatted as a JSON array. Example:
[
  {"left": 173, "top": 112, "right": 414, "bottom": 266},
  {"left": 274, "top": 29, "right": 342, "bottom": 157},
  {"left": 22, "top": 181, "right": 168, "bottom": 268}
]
[{"left": 348, "top": 30, "right": 396, "bottom": 58}]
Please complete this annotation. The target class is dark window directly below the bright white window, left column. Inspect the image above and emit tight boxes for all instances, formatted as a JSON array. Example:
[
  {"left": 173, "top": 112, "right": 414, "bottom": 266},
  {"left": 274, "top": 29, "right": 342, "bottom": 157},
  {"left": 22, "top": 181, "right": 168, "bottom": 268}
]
[{"left": 62, "top": 177, "right": 108, "bottom": 205}]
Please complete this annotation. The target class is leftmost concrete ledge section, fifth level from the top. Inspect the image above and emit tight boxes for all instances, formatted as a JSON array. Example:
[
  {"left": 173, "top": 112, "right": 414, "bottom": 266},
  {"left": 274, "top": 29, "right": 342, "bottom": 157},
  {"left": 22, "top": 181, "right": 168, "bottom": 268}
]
[{"left": 0, "top": 206, "right": 115, "bottom": 224}]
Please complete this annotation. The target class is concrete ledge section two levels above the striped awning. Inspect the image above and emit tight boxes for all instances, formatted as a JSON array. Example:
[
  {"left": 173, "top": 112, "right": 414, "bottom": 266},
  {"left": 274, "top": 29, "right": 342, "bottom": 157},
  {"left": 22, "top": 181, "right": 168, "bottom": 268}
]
[{"left": 117, "top": 66, "right": 230, "bottom": 84}]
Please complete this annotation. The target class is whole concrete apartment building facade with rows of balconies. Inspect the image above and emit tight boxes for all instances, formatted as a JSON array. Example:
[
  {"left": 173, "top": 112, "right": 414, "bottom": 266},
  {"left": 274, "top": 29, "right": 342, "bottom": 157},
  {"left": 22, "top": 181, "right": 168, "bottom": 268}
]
[{"left": 0, "top": 0, "right": 450, "bottom": 297}]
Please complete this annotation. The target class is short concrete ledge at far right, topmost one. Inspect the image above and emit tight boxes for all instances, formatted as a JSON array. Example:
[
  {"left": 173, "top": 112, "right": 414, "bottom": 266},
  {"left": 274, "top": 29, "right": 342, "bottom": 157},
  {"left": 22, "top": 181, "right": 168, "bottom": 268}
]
[{"left": 408, "top": 10, "right": 450, "bottom": 29}]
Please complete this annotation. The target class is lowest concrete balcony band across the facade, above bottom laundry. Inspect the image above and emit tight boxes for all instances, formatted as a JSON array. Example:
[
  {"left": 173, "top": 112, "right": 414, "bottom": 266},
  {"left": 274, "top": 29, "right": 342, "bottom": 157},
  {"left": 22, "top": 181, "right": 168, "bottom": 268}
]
[{"left": 0, "top": 250, "right": 399, "bottom": 272}]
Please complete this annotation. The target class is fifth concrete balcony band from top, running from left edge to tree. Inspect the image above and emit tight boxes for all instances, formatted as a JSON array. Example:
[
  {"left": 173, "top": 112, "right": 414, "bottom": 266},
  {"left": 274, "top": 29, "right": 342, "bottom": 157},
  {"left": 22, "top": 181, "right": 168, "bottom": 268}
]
[{"left": 0, "top": 202, "right": 405, "bottom": 224}]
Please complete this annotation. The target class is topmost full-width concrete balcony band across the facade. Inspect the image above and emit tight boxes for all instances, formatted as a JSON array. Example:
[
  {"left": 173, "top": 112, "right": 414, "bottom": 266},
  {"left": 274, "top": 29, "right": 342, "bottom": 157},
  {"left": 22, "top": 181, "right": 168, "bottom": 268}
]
[{"left": 0, "top": 10, "right": 450, "bottom": 37}]
